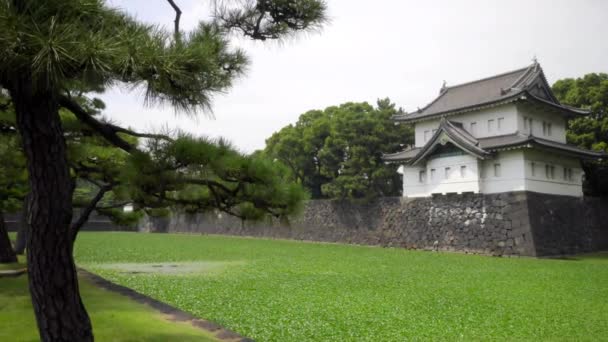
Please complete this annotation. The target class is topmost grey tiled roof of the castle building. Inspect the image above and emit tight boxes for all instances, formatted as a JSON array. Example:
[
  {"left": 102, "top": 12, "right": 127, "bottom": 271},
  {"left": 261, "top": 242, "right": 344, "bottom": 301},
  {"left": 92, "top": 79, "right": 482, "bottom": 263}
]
[{"left": 394, "top": 62, "right": 586, "bottom": 121}]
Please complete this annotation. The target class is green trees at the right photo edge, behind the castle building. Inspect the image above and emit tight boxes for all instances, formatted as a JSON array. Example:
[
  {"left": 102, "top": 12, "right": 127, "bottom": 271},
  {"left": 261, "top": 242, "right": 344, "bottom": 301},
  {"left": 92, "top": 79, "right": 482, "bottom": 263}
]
[{"left": 552, "top": 73, "right": 608, "bottom": 195}]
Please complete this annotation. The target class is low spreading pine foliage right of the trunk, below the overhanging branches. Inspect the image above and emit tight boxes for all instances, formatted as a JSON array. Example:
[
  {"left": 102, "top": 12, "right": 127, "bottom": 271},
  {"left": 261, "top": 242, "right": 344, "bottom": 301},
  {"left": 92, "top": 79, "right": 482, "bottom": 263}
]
[{"left": 127, "top": 134, "right": 307, "bottom": 220}]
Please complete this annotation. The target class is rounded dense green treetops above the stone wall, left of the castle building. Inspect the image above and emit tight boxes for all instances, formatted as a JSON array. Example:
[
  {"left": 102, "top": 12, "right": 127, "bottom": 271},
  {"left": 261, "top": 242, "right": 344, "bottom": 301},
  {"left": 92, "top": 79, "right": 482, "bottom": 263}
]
[{"left": 263, "top": 99, "right": 413, "bottom": 199}]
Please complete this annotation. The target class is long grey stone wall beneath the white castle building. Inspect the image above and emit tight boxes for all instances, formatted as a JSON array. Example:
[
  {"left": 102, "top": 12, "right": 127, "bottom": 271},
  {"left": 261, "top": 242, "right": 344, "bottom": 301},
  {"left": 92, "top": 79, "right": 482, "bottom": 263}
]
[{"left": 140, "top": 192, "right": 608, "bottom": 256}]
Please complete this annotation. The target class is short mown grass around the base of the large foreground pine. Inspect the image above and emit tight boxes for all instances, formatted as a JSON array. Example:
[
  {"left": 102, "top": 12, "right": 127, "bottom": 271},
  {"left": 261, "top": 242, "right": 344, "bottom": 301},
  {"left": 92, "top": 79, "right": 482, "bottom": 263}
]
[{"left": 0, "top": 255, "right": 216, "bottom": 342}]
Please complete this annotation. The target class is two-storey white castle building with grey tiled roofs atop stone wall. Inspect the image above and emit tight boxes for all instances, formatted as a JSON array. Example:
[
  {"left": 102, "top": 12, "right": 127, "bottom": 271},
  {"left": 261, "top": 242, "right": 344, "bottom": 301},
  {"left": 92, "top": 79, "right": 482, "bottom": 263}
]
[{"left": 384, "top": 61, "right": 606, "bottom": 197}]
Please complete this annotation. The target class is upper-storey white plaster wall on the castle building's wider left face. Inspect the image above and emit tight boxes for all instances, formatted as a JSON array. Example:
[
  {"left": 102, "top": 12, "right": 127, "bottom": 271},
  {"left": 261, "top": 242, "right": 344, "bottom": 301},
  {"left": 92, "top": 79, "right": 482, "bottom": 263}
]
[{"left": 415, "top": 104, "right": 523, "bottom": 147}]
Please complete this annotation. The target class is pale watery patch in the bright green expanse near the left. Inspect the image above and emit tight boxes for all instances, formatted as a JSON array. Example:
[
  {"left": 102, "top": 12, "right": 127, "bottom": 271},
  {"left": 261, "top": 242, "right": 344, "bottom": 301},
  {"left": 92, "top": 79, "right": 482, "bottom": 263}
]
[{"left": 95, "top": 261, "right": 243, "bottom": 275}]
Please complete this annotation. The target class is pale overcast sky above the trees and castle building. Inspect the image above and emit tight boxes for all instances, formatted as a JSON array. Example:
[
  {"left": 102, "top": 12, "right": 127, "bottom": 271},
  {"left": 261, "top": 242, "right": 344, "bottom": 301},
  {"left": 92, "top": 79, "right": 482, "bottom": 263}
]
[{"left": 103, "top": 0, "right": 608, "bottom": 152}]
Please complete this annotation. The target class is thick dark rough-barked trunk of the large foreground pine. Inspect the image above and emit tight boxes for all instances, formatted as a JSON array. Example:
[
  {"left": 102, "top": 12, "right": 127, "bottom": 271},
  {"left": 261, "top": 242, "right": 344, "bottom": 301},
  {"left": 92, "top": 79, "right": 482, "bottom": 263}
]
[{"left": 10, "top": 79, "right": 93, "bottom": 341}]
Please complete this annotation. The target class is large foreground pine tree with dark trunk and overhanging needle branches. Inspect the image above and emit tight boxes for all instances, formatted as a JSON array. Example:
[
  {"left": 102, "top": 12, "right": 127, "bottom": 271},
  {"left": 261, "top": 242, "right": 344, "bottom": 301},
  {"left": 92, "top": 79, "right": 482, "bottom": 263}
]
[{"left": 0, "top": 0, "right": 325, "bottom": 341}]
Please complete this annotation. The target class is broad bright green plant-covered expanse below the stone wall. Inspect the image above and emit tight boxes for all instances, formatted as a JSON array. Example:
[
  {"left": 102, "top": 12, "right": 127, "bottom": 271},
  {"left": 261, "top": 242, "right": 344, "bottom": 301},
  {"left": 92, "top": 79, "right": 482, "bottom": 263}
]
[{"left": 76, "top": 233, "right": 608, "bottom": 341}]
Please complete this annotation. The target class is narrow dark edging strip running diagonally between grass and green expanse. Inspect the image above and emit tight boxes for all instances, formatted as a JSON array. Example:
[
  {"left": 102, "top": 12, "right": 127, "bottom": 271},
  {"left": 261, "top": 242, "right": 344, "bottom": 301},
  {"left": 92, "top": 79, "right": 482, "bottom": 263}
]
[{"left": 78, "top": 268, "right": 253, "bottom": 342}]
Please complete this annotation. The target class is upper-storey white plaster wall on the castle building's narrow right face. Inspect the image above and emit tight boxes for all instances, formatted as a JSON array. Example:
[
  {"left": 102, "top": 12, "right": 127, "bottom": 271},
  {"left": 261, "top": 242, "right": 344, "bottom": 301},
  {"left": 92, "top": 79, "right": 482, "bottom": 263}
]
[{"left": 517, "top": 104, "right": 566, "bottom": 143}]
